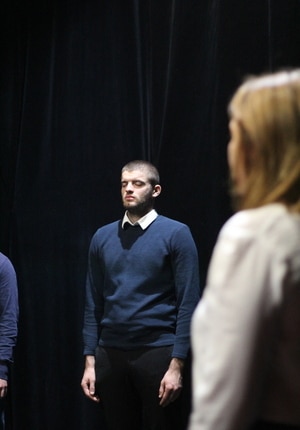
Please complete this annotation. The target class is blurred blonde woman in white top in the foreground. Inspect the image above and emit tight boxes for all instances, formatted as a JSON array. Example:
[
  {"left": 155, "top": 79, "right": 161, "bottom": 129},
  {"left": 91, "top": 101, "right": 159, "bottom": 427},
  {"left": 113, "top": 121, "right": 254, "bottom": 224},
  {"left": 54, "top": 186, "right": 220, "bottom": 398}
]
[{"left": 189, "top": 70, "right": 300, "bottom": 430}]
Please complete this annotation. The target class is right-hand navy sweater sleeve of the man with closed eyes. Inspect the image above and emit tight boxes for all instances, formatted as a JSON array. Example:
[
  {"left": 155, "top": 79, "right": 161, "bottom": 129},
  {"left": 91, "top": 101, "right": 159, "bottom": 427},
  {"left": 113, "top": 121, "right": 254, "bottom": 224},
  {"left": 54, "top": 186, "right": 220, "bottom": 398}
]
[{"left": 171, "top": 225, "right": 200, "bottom": 359}]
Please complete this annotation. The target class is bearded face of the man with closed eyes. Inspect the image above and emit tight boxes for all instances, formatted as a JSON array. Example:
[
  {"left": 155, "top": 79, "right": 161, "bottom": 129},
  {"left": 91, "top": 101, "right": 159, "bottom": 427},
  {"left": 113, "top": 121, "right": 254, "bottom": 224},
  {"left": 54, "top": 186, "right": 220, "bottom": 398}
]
[{"left": 121, "top": 170, "right": 160, "bottom": 216}]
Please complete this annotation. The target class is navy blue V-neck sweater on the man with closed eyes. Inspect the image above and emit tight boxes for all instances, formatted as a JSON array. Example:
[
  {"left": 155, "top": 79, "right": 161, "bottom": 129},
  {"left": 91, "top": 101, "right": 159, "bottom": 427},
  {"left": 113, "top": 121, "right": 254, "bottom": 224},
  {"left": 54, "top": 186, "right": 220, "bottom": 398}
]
[{"left": 83, "top": 215, "right": 200, "bottom": 359}]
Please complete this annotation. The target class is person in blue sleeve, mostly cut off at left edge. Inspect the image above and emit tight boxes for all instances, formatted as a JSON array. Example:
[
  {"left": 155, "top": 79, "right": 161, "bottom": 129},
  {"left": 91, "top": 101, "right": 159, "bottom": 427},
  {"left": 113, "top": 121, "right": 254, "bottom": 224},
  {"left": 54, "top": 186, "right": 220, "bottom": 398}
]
[{"left": 0, "top": 252, "right": 18, "bottom": 430}]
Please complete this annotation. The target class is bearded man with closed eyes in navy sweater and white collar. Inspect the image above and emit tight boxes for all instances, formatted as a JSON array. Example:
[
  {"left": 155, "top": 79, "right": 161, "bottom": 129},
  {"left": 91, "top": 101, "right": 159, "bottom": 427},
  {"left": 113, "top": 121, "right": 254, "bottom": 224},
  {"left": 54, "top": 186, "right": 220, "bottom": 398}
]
[{"left": 81, "top": 160, "right": 200, "bottom": 430}]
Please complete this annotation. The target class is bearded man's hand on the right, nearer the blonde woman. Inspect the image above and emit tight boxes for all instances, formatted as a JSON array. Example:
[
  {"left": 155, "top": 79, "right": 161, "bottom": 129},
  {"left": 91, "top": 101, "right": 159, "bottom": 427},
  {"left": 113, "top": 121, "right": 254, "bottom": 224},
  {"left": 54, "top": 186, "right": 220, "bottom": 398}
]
[{"left": 158, "top": 358, "right": 184, "bottom": 407}]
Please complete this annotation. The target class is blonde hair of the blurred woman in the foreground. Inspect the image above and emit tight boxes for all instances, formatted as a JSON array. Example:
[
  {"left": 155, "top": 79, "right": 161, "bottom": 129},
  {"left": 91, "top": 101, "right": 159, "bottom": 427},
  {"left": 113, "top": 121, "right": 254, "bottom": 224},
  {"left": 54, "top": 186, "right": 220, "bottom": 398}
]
[{"left": 229, "top": 70, "right": 300, "bottom": 212}]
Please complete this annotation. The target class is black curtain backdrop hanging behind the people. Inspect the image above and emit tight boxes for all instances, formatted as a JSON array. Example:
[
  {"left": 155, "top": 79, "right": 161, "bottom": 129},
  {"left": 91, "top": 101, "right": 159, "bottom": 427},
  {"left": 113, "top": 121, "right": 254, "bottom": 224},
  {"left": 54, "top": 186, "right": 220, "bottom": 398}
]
[{"left": 0, "top": 0, "right": 300, "bottom": 430}]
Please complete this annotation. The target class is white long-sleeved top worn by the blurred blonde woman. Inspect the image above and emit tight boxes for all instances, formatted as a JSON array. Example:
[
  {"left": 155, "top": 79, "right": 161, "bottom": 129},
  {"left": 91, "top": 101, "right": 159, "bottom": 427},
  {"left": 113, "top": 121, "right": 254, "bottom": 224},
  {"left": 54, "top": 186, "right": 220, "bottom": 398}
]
[{"left": 189, "top": 204, "right": 300, "bottom": 430}]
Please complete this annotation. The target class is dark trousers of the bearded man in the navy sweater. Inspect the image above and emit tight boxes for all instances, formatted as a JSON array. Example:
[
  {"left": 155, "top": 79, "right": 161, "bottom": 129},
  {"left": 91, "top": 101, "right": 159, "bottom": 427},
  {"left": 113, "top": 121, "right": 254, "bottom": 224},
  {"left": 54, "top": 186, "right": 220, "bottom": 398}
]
[{"left": 95, "top": 346, "right": 190, "bottom": 430}]
